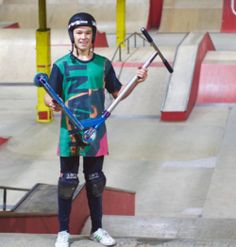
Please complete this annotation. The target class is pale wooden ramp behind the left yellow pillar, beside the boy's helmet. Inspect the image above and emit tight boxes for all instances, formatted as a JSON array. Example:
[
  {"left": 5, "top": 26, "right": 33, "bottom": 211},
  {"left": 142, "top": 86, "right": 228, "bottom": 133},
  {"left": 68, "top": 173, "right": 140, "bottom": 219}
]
[{"left": 0, "top": 29, "right": 106, "bottom": 83}]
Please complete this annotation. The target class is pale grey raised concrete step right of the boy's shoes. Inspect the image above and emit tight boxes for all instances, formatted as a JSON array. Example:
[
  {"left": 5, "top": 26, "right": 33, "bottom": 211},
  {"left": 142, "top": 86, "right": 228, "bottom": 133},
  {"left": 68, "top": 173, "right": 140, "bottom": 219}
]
[{"left": 81, "top": 215, "right": 236, "bottom": 242}]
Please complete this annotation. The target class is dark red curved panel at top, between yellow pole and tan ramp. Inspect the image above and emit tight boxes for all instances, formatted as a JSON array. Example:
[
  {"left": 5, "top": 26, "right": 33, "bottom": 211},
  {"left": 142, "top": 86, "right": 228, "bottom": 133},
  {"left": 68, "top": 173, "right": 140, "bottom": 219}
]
[{"left": 147, "top": 0, "right": 163, "bottom": 30}]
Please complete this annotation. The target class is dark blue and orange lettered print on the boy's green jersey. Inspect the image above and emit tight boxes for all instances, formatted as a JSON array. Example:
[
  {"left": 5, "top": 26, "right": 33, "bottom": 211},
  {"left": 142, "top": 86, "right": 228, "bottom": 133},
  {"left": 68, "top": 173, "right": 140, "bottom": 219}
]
[{"left": 64, "top": 62, "right": 104, "bottom": 155}]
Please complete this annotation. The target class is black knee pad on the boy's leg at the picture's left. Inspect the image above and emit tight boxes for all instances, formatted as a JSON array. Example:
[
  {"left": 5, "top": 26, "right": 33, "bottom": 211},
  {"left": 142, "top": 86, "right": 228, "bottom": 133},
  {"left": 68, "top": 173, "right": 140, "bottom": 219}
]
[{"left": 58, "top": 172, "right": 79, "bottom": 200}]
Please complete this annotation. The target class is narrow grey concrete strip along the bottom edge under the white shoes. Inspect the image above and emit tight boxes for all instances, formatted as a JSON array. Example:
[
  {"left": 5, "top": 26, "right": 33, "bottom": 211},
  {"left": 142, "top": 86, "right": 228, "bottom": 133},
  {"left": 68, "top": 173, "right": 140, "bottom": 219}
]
[{"left": 3, "top": 234, "right": 232, "bottom": 247}]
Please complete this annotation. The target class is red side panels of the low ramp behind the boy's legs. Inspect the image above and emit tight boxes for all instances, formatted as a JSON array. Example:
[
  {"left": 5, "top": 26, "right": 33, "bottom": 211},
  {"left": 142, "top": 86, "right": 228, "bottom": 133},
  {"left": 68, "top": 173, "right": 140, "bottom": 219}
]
[{"left": 0, "top": 186, "right": 135, "bottom": 234}]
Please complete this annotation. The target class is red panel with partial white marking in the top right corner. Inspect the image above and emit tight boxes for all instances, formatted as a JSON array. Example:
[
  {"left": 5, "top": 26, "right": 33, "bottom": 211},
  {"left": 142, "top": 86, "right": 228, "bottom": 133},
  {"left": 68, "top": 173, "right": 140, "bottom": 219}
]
[{"left": 221, "top": 0, "right": 236, "bottom": 32}]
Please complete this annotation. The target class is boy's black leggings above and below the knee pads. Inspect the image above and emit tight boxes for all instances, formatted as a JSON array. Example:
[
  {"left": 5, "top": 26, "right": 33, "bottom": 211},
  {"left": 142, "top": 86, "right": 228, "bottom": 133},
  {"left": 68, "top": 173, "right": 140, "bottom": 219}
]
[{"left": 58, "top": 156, "right": 104, "bottom": 232}]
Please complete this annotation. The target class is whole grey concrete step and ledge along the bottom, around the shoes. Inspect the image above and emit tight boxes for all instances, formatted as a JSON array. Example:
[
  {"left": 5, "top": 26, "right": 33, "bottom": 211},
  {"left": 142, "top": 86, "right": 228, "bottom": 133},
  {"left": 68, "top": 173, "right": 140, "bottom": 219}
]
[{"left": 0, "top": 216, "right": 236, "bottom": 247}]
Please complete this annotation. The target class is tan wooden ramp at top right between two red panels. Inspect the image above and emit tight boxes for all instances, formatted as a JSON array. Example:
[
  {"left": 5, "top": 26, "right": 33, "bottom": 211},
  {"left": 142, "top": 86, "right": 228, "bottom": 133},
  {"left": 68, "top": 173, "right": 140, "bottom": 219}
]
[{"left": 159, "top": 0, "right": 223, "bottom": 32}]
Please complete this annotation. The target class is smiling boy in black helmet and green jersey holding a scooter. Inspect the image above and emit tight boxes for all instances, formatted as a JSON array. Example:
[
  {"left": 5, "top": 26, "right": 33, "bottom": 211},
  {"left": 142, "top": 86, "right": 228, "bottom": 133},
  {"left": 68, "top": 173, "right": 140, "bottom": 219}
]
[{"left": 45, "top": 12, "right": 147, "bottom": 247}]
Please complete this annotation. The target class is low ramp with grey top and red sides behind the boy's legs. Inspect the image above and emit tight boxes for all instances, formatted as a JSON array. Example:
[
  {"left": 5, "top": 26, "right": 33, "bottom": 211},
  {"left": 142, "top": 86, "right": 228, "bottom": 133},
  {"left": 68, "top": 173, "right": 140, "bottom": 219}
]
[{"left": 0, "top": 184, "right": 135, "bottom": 234}]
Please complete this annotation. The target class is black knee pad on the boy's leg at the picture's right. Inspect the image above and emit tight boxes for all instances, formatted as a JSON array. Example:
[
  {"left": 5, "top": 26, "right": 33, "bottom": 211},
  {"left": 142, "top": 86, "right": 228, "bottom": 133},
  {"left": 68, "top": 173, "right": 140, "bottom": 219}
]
[{"left": 86, "top": 172, "right": 106, "bottom": 197}]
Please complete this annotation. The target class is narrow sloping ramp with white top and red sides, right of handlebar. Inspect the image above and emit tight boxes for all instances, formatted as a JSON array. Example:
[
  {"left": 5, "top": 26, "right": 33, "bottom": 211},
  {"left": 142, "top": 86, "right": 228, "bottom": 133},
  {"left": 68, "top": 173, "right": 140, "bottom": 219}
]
[{"left": 161, "top": 33, "right": 215, "bottom": 121}]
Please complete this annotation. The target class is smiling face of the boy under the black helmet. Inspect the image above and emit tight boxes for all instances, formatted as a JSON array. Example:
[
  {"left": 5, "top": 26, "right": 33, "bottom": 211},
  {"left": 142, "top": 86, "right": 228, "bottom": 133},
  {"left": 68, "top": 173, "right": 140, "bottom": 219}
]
[{"left": 73, "top": 26, "right": 93, "bottom": 51}]
